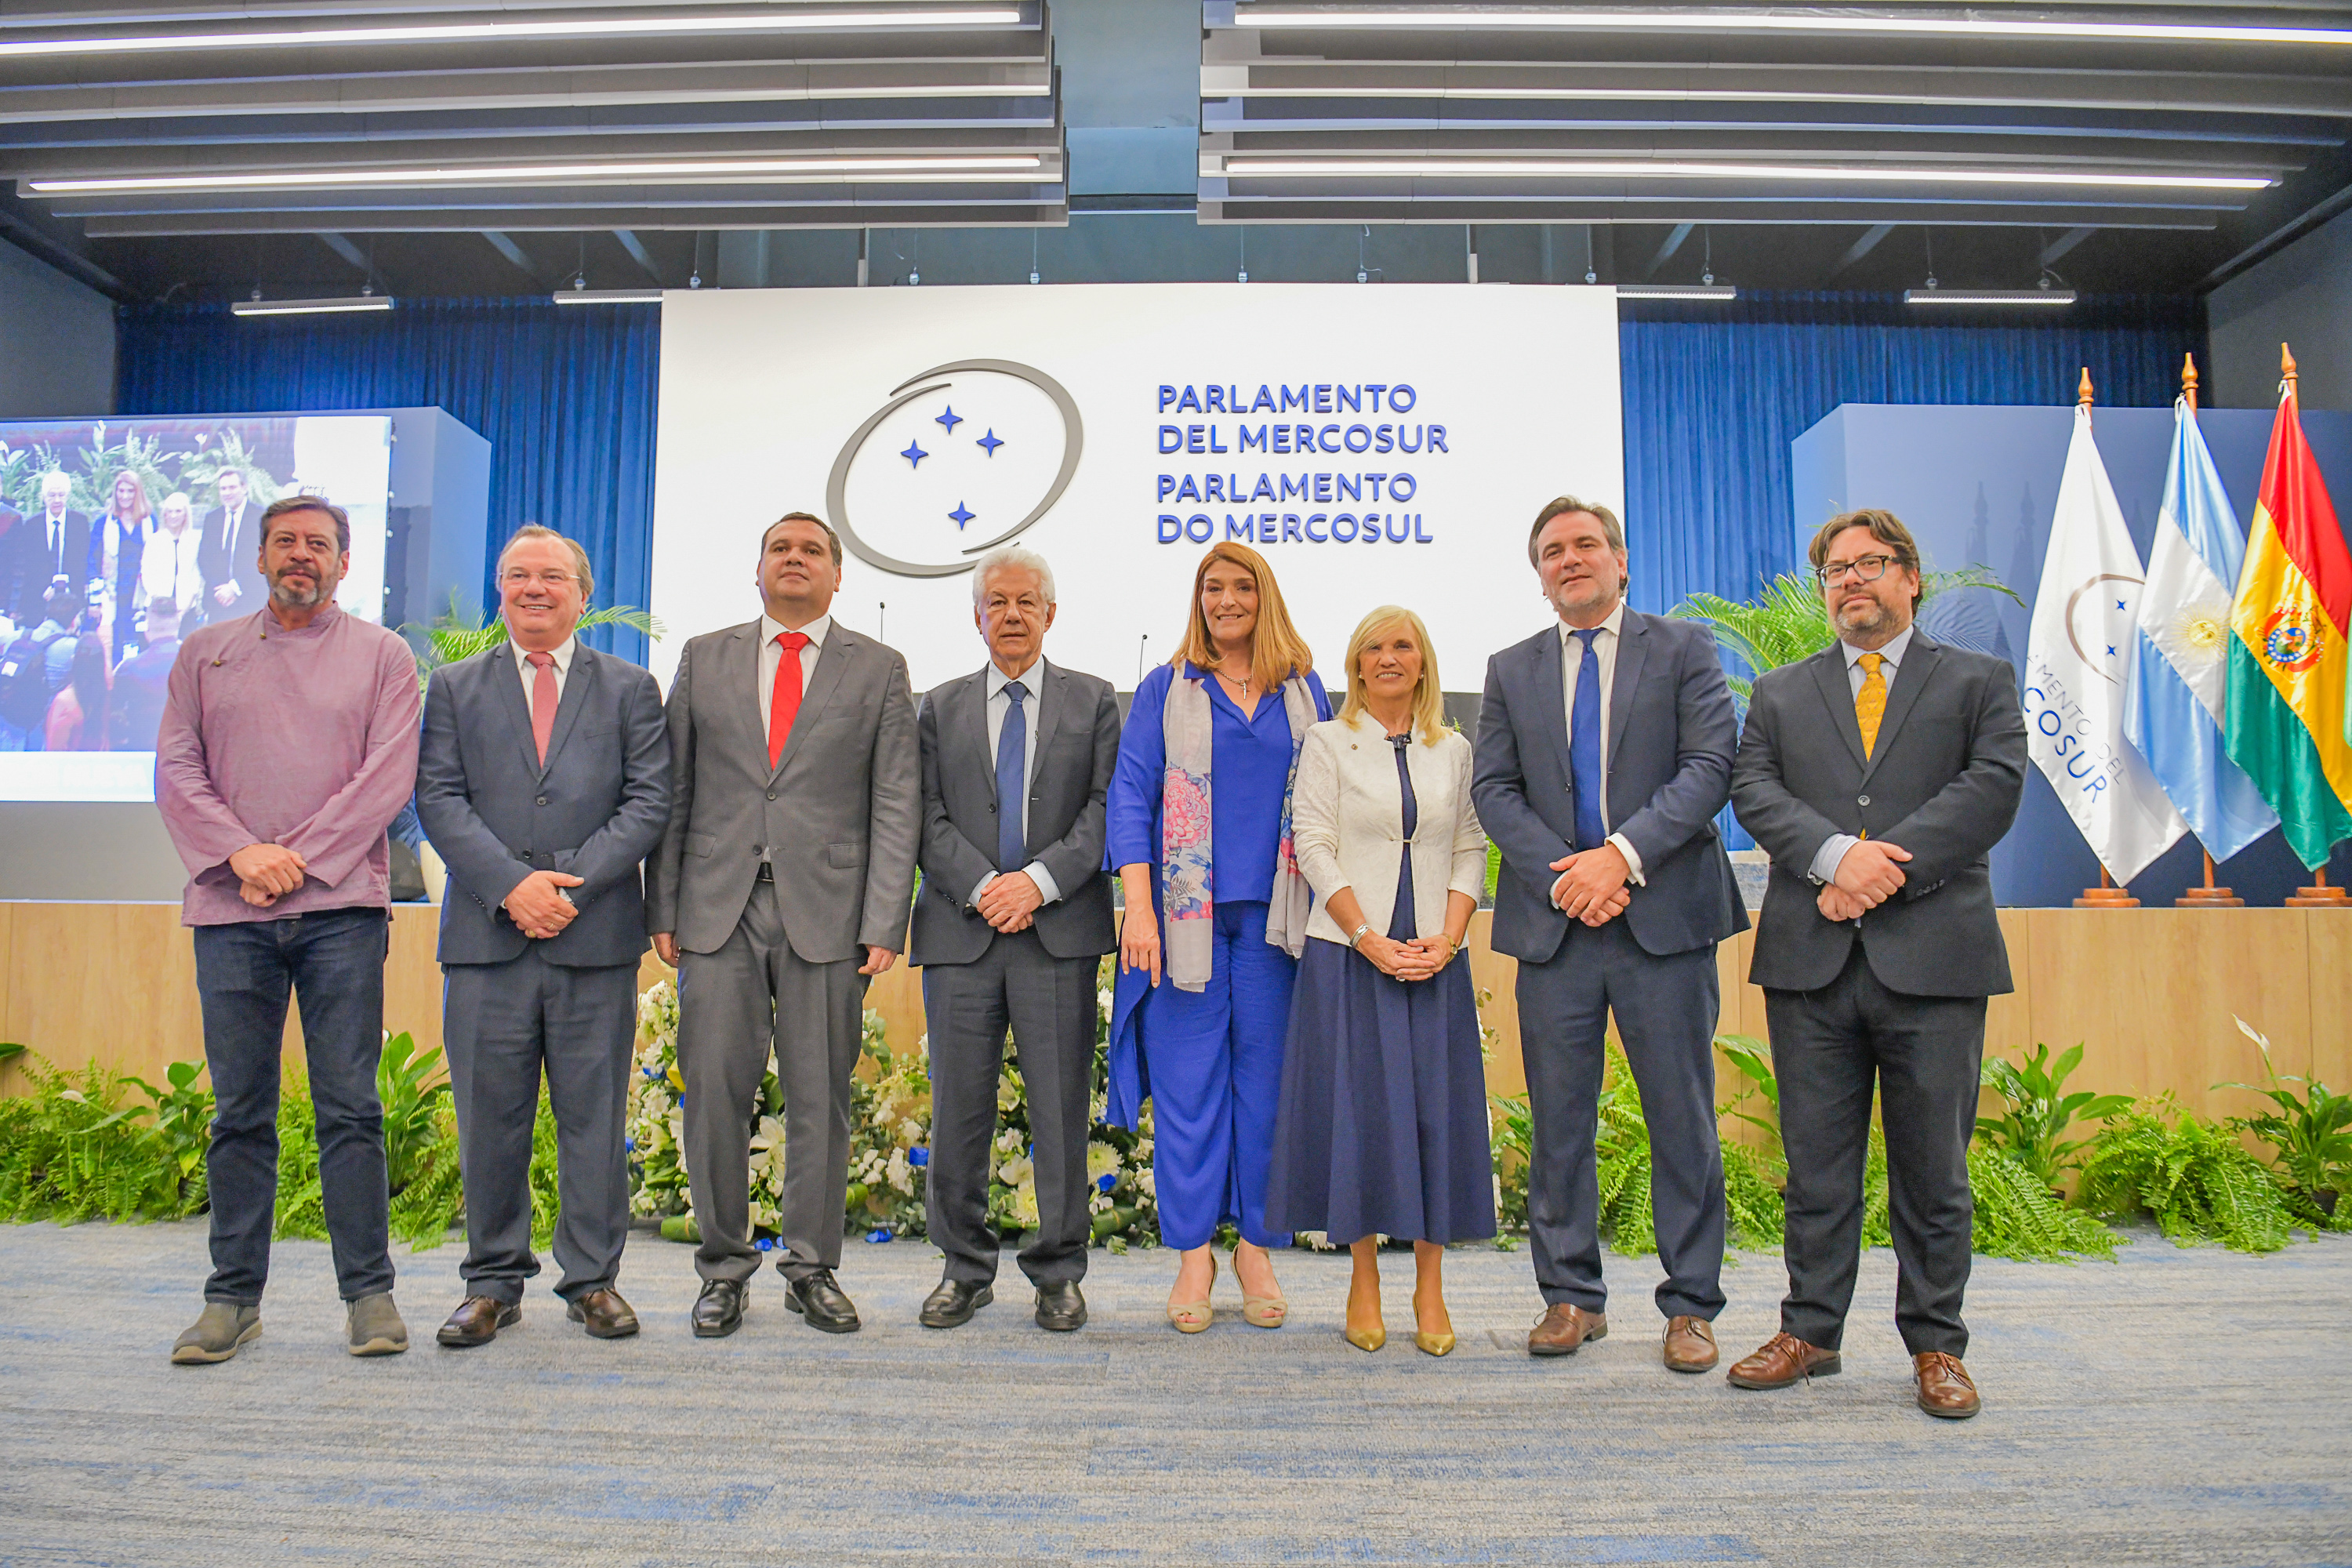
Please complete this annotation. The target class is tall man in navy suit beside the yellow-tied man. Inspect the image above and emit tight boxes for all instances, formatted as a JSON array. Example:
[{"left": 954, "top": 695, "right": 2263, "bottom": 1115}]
[{"left": 1470, "top": 496, "right": 1748, "bottom": 1373}]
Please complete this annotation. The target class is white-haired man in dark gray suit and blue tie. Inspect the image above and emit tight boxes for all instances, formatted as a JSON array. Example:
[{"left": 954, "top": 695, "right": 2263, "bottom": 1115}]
[{"left": 910, "top": 546, "right": 1120, "bottom": 1330}]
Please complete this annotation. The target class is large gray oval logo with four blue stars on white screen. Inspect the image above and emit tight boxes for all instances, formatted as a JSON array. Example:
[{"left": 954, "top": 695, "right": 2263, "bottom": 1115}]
[{"left": 826, "top": 360, "right": 1084, "bottom": 576}]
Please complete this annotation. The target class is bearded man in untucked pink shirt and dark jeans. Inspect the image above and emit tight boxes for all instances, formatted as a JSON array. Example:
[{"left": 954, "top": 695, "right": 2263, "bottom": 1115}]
[{"left": 155, "top": 496, "right": 421, "bottom": 1363}]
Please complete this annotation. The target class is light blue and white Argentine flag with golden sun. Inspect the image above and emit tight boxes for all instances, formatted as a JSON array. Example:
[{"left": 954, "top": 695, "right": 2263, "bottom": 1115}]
[{"left": 2124, "top": 400, "right": 2279, "bottom": 860}]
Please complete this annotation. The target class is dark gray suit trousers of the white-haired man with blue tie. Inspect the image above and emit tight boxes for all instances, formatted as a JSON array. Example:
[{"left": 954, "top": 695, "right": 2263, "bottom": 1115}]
[{"left": 922, "top": 926, "right": 1096, "bottom": 1286}]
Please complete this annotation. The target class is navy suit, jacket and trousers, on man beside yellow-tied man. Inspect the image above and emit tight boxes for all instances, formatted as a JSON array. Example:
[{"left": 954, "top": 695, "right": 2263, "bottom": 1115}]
[{"left": 1470, "top": 609, "right": 1748, "bottom": 1319}]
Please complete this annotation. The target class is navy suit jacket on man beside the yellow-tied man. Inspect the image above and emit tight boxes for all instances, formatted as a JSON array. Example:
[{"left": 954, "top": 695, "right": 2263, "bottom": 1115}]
[{"left": 1470, "top": 609, "right": 1748, "bottom": 964}]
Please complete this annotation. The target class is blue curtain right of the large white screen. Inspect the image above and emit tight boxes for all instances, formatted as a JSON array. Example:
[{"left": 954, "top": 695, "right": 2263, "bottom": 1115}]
[{"left": 1618, "top": 294, "right": 2206, "bottom": 614}]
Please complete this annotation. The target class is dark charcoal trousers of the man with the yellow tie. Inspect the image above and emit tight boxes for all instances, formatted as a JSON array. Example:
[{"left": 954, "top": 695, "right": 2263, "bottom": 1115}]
[{"left": 1764, "top": 945, "right": 1985, "bottom": 1356}]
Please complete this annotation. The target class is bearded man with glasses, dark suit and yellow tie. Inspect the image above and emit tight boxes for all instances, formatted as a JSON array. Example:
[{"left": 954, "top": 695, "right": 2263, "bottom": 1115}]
[{"left": 1731, "top": 510, "right": 2025, "bottom": 1420}]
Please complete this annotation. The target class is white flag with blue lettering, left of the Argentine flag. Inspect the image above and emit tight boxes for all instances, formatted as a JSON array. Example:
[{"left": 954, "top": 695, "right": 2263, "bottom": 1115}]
[{"left": 2025, "top": 407, "right": 2190, "bottom": 884}]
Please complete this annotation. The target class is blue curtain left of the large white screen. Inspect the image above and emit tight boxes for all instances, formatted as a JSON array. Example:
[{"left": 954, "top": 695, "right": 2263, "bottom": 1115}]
[{"left": 115, "top": 299, "right": 661, "bottom": 663}]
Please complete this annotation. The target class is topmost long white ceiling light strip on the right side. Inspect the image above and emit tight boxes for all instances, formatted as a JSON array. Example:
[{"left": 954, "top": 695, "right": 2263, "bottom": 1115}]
[{"left": 1232, "top": 7, "right": 2352, "bottom": 45}]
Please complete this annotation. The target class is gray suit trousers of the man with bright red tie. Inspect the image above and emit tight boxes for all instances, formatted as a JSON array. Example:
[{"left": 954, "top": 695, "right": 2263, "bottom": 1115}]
[{"left": 677, "top": 881, "right": 866, "bottom": 1281}]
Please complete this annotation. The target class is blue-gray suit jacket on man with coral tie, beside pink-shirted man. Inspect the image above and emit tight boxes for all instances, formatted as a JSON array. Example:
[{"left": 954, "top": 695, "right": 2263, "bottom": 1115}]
[{"left": 416, "top": 644, "right": 670, "bottom": 968}]
